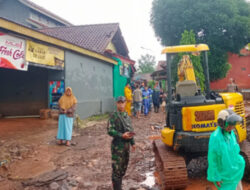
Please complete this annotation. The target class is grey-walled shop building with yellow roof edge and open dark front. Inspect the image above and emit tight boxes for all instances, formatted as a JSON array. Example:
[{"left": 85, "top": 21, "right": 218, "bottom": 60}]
[{"left": 0, "top": 18, "right": 117, "bottom": 118}]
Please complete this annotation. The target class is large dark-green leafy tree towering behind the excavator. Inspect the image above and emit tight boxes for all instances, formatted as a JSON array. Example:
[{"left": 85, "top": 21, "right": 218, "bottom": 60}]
[{"left": 151, "top": 0, "right": 250, "bottom": 80}]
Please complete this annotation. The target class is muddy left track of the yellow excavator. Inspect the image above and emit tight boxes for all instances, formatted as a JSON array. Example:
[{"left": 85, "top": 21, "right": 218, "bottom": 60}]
[{"left": 153, "top": 140, "right": 188, "bottom": 190}]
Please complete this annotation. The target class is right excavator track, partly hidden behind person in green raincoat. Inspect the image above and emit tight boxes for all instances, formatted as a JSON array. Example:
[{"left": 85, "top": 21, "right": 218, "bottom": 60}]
[{"left": 240, "top": 140, "right": 250, "bottom": 181}]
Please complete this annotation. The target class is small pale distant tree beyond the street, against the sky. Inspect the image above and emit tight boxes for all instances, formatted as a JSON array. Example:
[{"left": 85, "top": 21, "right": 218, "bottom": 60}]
[{"left": 138, "top": 54, "right": 156, "bottom": 73}]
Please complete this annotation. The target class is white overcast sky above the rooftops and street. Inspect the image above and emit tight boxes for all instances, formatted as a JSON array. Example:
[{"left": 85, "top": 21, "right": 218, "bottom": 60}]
[{"left": 32, "top": 0, "right": 164, "bottom": 64}]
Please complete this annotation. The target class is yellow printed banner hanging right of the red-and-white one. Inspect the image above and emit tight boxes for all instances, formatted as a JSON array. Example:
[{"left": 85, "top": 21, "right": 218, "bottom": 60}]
[{"left": 26, "top": 41, "right": 64, "bottom": 68}]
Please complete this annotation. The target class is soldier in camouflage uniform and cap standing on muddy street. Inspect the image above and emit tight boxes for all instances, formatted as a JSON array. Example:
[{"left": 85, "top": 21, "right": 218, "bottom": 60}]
[{"left": 108, "top": 96, "right": 135, "bottom": 190}]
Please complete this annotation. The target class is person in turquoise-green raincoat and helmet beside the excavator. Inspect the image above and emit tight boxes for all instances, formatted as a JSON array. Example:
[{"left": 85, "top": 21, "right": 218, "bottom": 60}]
[{"left": 207, "top": 110, "right": 245, "bottom": 190}]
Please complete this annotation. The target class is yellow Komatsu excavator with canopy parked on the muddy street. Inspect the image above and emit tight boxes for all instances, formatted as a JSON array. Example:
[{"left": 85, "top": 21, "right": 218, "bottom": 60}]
[{"left": 153, "top": 44, "right": 250, "bottom": 189}]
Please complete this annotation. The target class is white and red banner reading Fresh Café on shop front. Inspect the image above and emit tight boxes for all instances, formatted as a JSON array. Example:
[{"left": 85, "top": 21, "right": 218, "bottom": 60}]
[{"left": 0, "top": 32, "right": 28, "bottom": 71}]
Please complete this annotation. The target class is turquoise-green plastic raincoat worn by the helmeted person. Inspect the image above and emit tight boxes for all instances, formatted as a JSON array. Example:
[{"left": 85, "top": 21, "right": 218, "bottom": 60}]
[{"left": 207, "top": 127, "right": 245, "bottom": 190}]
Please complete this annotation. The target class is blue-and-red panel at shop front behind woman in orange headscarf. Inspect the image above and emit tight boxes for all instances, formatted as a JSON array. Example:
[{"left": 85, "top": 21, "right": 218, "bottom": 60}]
[{"left": 49, "top": 81, "right": 64, "bottom": 109}]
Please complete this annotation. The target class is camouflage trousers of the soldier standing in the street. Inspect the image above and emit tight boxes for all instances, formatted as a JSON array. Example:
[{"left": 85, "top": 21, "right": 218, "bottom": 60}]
[{"left": 111, "top": 142, "right": 130, "bottom": 181}]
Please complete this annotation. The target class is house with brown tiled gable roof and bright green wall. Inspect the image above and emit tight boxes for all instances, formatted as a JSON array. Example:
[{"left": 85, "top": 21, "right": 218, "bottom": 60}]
[{"left": 40, "top": 23, "right": 136, "bottom": 97}]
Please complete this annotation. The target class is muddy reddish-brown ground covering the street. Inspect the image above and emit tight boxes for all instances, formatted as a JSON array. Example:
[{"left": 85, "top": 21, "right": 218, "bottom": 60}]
[{"left": 0, "top": 108, "right": 250, "bottom": 190}]
